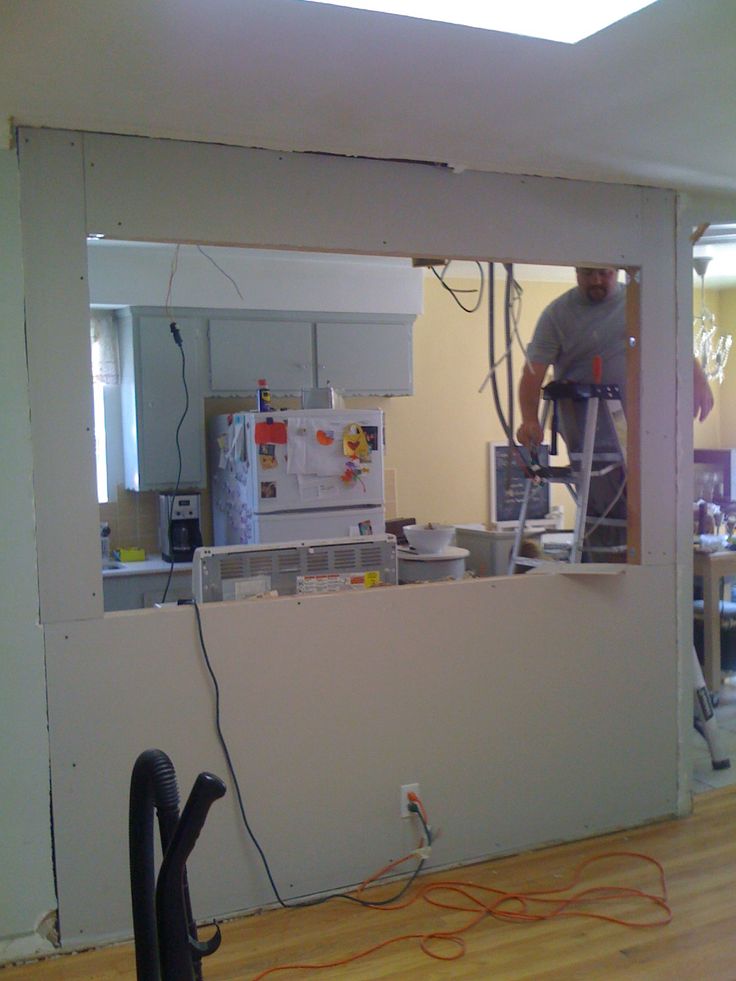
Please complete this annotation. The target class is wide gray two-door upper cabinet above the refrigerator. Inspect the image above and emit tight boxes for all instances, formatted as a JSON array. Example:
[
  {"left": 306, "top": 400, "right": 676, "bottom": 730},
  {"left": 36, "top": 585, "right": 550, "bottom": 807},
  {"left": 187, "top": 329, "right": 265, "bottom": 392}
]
[{"left": 209, "top": 313, "right": 414, "bottom": 396}]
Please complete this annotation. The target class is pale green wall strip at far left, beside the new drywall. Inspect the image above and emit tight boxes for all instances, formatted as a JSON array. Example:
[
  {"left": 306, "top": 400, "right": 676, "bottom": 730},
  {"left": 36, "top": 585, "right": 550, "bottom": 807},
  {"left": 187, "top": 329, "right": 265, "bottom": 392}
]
[{"left": 0, "top": 150, "right": 56, "bottom": 960}]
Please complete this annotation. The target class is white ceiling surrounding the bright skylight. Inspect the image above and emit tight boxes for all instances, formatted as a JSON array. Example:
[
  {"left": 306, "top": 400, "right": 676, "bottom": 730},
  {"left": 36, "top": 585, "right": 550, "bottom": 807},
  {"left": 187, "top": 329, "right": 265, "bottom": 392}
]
[{"left": 0, "top": 0, "right": 736, "bottom": 280}]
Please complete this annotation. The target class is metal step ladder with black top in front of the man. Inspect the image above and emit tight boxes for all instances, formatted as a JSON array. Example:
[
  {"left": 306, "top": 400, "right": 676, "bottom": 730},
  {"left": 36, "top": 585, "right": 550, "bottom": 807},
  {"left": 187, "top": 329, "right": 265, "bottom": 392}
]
[{"left": 508, "top": 381, "right": 626, "bottom": 575}]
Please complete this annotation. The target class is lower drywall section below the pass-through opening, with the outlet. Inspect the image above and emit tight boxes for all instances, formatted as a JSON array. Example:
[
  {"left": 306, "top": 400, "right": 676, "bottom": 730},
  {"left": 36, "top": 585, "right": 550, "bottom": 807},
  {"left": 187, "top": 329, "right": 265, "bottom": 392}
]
[{"left": 47, "top": 566, "right": 677, "bottom": 944}]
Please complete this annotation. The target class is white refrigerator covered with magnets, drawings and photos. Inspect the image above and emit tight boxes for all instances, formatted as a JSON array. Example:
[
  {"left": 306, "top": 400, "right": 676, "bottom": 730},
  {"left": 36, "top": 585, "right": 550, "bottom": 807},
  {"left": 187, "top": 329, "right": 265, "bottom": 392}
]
[{"left": 208, "top": 409, "right": 386, "bottom": 545}]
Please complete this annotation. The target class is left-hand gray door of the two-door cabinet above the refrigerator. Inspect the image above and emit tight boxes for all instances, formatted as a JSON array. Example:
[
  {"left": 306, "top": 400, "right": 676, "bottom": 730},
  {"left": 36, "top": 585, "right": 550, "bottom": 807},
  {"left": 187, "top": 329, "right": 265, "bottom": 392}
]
[{"left": 209, "top": 318, "right": 314, "bottom": 395}]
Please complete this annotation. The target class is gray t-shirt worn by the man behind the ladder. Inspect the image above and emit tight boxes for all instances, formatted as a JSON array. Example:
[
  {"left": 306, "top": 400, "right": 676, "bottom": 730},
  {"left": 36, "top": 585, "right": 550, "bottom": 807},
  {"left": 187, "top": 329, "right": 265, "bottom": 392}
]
[{"left": 527, "top": 283, "right": 626, "bottom": 450}]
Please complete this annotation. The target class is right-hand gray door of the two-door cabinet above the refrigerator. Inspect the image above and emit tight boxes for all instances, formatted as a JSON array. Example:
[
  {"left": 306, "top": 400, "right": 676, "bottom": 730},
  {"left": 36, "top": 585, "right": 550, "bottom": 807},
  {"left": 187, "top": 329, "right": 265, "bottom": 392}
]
[{"left": 317, "top": 318, "right": 413, "bottom": 395}]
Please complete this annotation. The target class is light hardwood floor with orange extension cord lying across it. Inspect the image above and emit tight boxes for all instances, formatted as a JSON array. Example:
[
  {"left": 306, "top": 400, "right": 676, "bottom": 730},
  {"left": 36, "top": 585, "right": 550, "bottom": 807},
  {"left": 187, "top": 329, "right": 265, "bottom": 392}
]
[{"left": 0, "top": 787, "right": 736, "bottom": 981}]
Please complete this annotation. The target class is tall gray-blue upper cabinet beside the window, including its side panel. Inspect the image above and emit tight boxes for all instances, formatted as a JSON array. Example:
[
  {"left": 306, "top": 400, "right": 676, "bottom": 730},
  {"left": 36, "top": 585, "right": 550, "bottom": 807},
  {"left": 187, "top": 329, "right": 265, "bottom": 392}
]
[{"left": 116, "top": 308, "right": 207, "bottom": 491}]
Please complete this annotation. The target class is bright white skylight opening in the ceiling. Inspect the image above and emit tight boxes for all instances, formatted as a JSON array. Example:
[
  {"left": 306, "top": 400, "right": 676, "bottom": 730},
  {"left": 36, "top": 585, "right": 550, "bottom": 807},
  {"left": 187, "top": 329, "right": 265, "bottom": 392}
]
[{"left": 302, "top": 0, "right": 655, "bottom": 44}]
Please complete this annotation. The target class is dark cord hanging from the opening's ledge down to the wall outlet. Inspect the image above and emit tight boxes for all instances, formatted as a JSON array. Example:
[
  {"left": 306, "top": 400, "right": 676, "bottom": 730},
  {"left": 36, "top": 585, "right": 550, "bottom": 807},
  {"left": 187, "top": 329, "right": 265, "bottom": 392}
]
[{"left": 191, "top": 601, "right": 432, "bottom": 909}]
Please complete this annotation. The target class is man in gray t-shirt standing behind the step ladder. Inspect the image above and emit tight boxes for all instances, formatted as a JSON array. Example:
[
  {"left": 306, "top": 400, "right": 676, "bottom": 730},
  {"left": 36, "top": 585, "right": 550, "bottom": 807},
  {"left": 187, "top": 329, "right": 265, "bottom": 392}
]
[{"left": 516, "top": 266, "right": 713, "bottom": 560}]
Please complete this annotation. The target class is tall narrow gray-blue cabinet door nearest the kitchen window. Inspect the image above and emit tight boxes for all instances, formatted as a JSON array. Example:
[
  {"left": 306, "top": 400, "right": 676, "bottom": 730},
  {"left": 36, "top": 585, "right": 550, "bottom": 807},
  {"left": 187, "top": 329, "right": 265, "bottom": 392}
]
[{"left": 131, "top": 315, "right": 206, "bottom": 490}]
